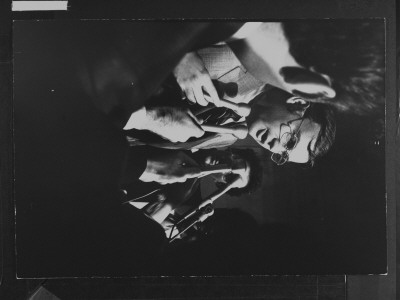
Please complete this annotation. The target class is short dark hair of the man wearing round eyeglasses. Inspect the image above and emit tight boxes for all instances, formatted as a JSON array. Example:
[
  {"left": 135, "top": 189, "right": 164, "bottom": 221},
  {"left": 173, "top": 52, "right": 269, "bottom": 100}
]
[{"left": 304, "top": 103, "right": 336, "bottom": 166}]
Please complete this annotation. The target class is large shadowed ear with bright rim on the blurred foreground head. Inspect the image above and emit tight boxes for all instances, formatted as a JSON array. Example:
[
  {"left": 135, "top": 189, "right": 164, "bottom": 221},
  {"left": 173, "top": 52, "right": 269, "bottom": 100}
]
[{"left": 279, "top": 67, "right": 336, "bottom": 98}]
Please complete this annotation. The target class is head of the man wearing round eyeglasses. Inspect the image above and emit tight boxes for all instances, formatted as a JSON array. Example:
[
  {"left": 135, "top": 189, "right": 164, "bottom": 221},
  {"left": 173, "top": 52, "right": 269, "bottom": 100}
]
[{"left": 247, "top": 88, "right": 336, "bottom": 165}]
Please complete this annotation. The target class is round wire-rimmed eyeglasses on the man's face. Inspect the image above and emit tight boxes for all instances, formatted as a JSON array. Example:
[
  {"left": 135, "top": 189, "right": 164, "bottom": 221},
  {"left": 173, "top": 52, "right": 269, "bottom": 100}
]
[{"left": 271, "top": 117, "right": 304, "bottom": 166}]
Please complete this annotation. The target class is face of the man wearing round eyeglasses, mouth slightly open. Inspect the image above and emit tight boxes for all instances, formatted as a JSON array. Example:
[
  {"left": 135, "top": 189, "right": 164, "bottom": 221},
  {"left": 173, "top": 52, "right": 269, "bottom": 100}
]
[{"left": 247, "top": 89, "right": 321, "bottom": 163}]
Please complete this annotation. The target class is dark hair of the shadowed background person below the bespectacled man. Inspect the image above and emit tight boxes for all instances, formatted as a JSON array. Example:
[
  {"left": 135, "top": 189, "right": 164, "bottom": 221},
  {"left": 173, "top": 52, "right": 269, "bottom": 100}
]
[{"left": 217, "top": 148, "right": 263, "bottom": 197}]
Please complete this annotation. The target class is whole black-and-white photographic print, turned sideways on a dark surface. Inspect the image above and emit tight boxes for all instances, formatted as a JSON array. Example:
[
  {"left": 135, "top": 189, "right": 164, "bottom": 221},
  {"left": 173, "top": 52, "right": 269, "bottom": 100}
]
[{"left": 13, "top": 18, "right": 387, "bottom": 278}]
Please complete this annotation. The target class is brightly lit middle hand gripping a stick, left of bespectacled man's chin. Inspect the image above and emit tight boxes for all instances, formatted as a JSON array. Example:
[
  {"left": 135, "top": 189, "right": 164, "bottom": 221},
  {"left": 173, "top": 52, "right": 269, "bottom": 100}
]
[{"left": 144, "top": 107, "right": 204, "bottom": 143}]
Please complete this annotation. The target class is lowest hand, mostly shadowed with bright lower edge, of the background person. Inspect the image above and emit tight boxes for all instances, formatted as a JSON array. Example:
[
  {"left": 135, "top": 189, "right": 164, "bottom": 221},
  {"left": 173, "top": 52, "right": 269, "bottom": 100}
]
[{"left": 139, "top": 151, "right": 201, "bottom": 184}]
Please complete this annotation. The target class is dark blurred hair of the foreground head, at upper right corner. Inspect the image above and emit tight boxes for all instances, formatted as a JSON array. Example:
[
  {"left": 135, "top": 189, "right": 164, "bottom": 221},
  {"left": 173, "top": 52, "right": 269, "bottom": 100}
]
[{"left": 282, "top": 19, "right": 385, "bottom": 115}]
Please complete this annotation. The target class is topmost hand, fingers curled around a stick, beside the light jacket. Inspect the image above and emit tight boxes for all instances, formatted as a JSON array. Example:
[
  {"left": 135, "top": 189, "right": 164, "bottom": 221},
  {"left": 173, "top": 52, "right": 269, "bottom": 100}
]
[{"left": 174, "top": 52, "right": 220, "bottom": 106}]
